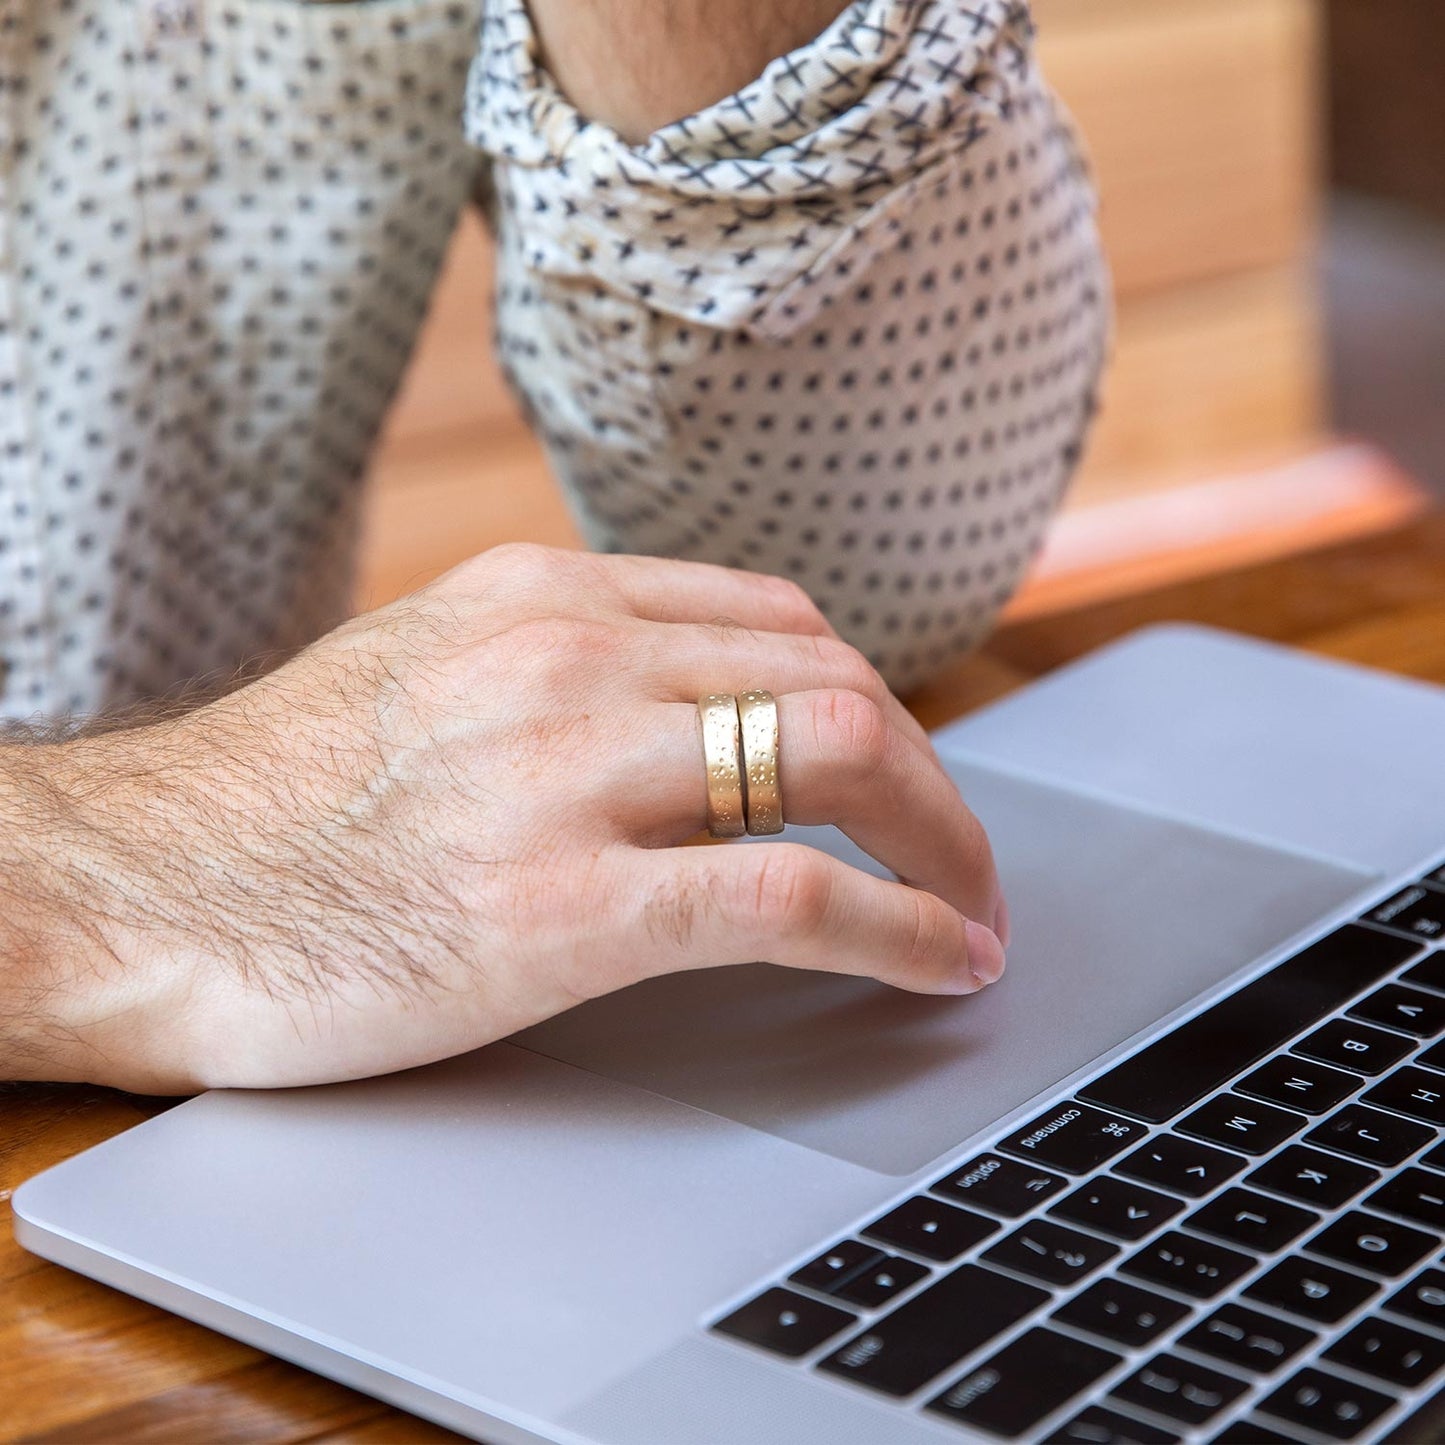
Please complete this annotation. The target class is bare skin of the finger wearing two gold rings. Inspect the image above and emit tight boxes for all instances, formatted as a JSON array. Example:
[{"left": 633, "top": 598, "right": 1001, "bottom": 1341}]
[{"left": 627, "top": 689, "right": 1001, "bottom": 928}]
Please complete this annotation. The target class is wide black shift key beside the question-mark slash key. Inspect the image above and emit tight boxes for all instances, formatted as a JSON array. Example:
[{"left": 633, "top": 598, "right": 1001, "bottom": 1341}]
[{"left": 818, "top": 1264, "right": 1049, "bottom": 1394}]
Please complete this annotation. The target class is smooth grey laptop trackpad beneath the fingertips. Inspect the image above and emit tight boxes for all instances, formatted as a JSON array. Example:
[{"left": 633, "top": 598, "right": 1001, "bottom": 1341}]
[{"left": 513, "top": 763, "right": 1370, "bottom": 1175}]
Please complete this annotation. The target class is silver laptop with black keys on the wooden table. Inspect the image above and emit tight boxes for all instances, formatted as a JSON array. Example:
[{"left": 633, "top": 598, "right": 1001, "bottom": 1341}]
[{"left": 14, "top": 626, "right": 1445, "bottom": 1445}]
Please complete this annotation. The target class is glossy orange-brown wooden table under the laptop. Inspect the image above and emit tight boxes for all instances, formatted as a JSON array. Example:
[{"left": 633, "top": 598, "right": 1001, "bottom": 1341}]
[{"left": 8, "top": 516, "right": 1445, "bottom": 1445}]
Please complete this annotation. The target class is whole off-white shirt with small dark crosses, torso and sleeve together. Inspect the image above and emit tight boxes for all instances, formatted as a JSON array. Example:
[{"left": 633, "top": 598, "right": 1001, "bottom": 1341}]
[{"left": 0, "top": 0, "right": 1107, "bottom": 720}]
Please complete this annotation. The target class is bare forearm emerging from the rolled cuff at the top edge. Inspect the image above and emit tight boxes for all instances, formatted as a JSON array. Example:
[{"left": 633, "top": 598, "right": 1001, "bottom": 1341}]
[{"left": 530, "top": 0, "right": 844, "bottom": 142}]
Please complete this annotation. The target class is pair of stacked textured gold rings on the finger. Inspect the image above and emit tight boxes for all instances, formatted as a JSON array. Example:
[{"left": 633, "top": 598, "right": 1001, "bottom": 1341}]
[{"left": 698, "top": 688, "right": 783, "bottom": 838}]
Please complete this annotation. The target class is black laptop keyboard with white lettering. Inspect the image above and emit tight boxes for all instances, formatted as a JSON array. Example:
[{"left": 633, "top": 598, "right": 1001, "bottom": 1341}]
[{"left": 712, "top": 867, "right": 1445, "bottom": 1445}]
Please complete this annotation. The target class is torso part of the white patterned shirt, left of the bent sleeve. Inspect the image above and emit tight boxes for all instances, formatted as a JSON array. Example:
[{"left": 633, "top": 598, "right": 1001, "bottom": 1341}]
[{"left": 0, "top": 0, "right": 478, "bottom": 718}]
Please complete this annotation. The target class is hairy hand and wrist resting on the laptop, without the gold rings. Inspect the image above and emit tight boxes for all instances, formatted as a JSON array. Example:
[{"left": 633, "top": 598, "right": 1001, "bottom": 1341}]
[{"left": 0, "top": 546, "right": 1004, "bottom": 1091}]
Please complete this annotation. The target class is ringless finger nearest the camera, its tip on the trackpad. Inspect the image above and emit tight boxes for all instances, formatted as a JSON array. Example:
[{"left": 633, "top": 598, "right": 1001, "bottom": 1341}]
[{"left": 616, "top": 842, "right": 1003, "bottom": 994}]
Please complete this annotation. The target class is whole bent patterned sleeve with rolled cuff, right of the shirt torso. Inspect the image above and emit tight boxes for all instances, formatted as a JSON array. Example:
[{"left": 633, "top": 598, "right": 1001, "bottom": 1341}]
[{"left": 467, "top": 0, "right": 1108, "bottom": 688}]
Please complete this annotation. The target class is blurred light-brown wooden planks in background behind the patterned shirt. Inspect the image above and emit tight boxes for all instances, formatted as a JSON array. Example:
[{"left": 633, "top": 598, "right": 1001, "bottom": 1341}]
[{"left": 361, "top": 0, "right": 1418, "bottom": 608}]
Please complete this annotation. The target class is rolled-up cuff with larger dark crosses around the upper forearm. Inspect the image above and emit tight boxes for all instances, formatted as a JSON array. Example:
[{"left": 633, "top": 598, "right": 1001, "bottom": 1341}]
[{"left": 467, "top": 0, "right": 1052, "bottom": 340}]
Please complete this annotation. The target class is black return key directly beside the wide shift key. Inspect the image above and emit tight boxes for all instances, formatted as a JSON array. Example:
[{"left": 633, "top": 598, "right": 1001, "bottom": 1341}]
[{"left": 928, "top": 1329, "right": 1123, "bottom": 1436}]
